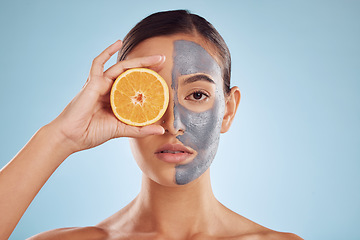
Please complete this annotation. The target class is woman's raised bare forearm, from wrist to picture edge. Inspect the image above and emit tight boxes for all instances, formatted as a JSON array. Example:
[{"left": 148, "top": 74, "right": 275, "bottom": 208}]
[{"left": 0, "top": 126, "right": 71, "bottom": 239}]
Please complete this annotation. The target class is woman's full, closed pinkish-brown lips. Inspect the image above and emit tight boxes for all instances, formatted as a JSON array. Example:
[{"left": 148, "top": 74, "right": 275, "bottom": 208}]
[{"left": 155, "top": 144, "right": 194, "bottom": 163}]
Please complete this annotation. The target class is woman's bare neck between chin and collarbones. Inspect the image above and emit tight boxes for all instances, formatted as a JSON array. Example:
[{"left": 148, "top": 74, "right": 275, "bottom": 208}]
[{"left": 134, "top": 169, "right": 221, "bottom": 237}]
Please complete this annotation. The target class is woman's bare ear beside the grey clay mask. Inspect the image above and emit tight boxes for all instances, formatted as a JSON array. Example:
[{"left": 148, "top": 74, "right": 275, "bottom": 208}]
[{"left": 220, "top": 87, "right": 241, "bottom": 133}]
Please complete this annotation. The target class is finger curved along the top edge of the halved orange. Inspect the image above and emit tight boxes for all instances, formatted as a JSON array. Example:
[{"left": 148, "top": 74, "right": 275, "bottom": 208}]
[{"left": 104, "top": 55, "right": 165, "bottom": 80}]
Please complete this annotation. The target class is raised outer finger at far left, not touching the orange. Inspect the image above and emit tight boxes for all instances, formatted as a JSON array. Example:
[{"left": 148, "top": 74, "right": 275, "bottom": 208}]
[{"left": 90, "top": 40, "right": 122, "bottom": 76}]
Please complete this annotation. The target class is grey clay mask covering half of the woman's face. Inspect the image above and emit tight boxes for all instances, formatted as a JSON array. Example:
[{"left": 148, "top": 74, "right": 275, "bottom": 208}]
[{"left": 171, "top": 40, "right": 225, "bottom": 185}]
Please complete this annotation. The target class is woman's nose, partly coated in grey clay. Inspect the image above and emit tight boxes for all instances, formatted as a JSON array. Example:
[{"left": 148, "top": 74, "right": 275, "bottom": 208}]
[{"left": 161, "top": 98, "right": 185, "bottom": 136}]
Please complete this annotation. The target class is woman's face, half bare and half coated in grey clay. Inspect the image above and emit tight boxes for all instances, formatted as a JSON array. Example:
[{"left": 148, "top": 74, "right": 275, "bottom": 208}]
[{"left": 127, "top": 34, "right": 225, "bottom": 186}]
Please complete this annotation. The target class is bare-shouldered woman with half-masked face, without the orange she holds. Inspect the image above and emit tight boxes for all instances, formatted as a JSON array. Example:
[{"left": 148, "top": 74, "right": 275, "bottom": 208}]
[{"left": 0, "top": 10, "right": 301, "bottom": 239}]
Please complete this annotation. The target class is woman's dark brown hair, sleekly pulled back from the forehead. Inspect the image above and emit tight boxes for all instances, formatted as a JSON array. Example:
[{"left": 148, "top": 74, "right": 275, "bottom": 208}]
[{"left": 118, "top": 10, "right": 231, "bottom": 94}]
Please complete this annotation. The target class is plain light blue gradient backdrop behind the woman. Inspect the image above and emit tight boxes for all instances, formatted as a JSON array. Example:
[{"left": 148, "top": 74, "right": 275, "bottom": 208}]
[{"left": 0, "top": 0, "right": 360, "bottom": 240}]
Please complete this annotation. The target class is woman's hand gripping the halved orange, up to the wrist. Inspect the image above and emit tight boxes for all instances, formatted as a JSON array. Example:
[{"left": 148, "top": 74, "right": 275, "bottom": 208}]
[{"left": 49, "top": 40, "right": 165, "bottom": 152}]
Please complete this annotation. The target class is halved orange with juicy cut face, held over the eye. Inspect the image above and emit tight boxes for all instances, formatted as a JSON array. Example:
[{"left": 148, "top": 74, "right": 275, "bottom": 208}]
[{"left": 110, "top": 68, "right": 169, "bottom": 126}]
